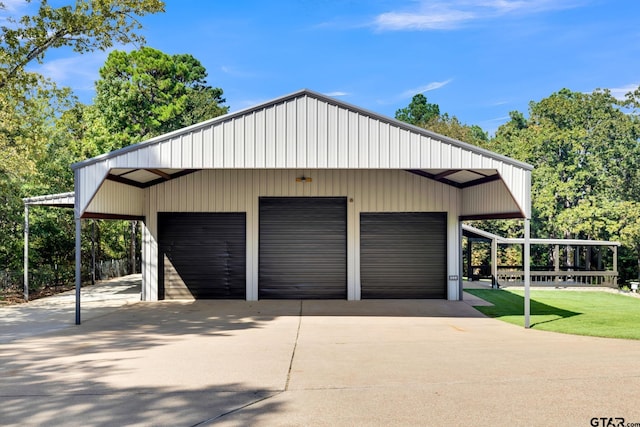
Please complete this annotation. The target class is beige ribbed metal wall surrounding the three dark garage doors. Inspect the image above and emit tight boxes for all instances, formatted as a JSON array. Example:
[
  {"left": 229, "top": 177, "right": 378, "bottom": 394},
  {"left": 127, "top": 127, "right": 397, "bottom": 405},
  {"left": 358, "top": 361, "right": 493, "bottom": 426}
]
[{"left": 141, "top": 169, "right": 462, "bottom": 300}]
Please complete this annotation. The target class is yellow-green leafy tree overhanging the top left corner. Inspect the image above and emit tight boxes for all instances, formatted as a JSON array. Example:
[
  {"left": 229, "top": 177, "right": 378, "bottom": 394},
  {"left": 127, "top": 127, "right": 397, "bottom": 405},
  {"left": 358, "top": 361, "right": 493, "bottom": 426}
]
[{"left": 0, "top": 0, "right": 164, "bottom": 173}]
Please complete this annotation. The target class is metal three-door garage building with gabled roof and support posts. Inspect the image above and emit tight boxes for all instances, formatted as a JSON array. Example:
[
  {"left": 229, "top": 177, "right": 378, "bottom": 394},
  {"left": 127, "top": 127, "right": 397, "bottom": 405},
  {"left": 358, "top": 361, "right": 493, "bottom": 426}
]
[{"left": 62, "top": 90, "right": 532, "bottom": 322}]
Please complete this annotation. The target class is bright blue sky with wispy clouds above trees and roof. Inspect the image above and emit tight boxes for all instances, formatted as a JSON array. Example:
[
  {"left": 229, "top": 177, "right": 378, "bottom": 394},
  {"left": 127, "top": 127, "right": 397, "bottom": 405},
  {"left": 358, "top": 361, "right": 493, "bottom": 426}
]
[{"left": 4, "top": 0, "right": 640, "bottom": 132}]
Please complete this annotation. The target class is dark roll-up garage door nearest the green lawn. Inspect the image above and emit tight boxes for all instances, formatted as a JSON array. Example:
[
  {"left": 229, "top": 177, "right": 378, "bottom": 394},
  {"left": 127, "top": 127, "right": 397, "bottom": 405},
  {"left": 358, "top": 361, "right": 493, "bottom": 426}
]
[{"left": 360, "top": 212, "right": 447, "bottom": 299}]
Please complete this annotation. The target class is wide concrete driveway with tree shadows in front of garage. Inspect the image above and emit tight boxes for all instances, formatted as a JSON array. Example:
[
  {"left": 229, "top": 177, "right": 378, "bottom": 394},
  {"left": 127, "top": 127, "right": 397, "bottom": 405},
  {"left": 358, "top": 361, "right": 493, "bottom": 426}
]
[{"left": 0, "top": 276, "right": 640, "bottom": 426}]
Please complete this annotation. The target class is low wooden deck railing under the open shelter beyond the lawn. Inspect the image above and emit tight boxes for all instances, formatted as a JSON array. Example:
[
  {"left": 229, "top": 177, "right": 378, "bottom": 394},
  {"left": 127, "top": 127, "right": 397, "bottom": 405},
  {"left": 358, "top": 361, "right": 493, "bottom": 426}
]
[{"left": 497, "top": 270, "right": 618, "bottom": 288}]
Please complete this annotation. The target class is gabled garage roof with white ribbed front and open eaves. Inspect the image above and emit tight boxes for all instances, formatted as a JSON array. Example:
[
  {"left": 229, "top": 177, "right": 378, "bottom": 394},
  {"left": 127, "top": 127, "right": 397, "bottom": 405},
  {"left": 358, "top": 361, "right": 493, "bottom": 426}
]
[{"left": 72, "top": 89, "right": 532, "bottom": 218}]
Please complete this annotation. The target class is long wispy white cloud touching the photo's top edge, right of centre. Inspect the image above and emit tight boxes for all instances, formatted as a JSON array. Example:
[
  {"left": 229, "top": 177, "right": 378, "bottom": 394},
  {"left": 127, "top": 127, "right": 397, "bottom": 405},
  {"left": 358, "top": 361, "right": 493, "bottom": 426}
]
[{"left": 372, "top": 0, "right": 584, "bottom": 31}]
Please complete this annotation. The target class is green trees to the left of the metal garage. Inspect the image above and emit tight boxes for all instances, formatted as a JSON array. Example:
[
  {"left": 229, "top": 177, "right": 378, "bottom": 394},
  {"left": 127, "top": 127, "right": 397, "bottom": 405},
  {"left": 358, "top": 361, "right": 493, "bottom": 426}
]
[{"left": 0, "top": 0, "right": 228, "bottom": 294}]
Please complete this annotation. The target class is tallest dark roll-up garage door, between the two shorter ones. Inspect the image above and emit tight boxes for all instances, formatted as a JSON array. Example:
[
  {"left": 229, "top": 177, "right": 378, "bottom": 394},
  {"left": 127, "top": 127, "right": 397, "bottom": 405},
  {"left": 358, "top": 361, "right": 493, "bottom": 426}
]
[{"left": 258, "top": 197, "right": 347, "bottom": 299}]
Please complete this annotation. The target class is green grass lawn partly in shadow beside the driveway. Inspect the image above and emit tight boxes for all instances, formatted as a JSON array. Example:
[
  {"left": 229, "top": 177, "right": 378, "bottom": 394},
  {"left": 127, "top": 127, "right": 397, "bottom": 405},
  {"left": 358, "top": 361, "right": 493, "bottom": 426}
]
[{"left": 465, "top": 289, "right": 640, "bottom": 340}]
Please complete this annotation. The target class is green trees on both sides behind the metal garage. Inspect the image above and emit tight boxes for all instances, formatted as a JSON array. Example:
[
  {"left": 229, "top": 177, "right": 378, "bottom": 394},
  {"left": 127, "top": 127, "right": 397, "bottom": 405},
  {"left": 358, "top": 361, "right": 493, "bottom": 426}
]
[{"left": 0, "top": 0, "right": 640, "bottom": 298}]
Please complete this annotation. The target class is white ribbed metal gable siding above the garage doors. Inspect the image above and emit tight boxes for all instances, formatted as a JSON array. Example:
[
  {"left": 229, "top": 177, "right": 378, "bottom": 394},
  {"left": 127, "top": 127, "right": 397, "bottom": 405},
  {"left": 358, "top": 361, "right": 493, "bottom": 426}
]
[{"left": 77, "top": 94, "right": 529, "bottom": 221}]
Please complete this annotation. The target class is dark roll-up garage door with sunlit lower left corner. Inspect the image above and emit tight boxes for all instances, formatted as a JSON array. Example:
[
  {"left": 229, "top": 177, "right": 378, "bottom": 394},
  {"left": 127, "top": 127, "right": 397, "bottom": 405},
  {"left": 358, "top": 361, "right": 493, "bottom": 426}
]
[{"left": 158, "top": 212, "right": 246, "bottom": 299}]
